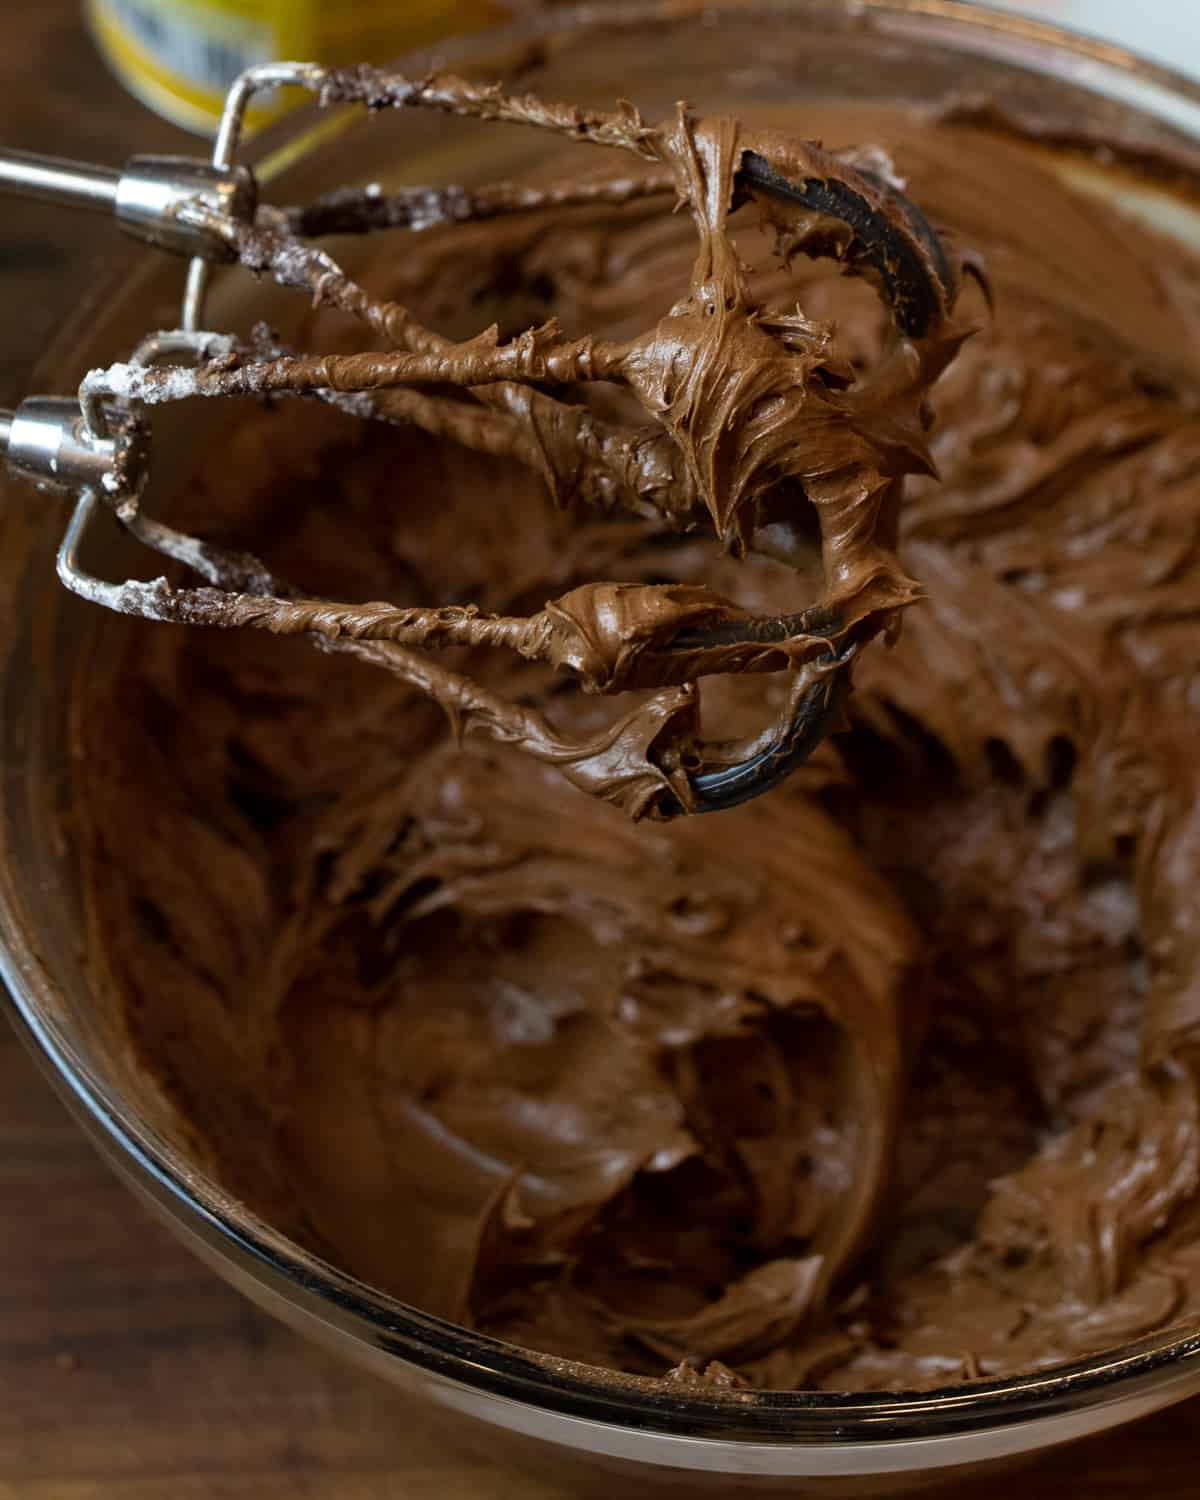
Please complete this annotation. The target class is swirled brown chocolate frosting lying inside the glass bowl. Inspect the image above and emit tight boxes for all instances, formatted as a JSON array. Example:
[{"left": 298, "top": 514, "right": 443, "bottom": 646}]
[{"left": 78, "top": 96, "right": 1200, "bottom": 1389}]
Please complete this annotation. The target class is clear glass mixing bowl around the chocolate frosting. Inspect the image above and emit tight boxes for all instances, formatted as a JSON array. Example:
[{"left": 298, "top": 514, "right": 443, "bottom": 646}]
[{"left": 0, "top": 0, "right": 1200, "bottom": 1494}]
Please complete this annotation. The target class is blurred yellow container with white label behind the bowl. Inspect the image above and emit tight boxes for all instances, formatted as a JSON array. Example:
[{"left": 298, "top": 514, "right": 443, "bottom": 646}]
[{"left": 87, "top": 0, "right": 504, "bottom": 132}]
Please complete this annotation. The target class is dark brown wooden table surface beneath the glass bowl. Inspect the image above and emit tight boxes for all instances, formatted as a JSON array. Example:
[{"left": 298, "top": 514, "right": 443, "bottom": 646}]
[{"left": 0, "top": 0, "right": 1200, "bottom": 1500}]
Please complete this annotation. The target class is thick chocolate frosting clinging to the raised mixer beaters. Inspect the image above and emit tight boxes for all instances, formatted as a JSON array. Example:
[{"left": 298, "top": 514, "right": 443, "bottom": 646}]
[{"left": 89, "top": 76, "right": 965, "bottom": 818}]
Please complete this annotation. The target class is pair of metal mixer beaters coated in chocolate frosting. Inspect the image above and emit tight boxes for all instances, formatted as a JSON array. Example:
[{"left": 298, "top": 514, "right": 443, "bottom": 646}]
[{"left": 0, "top": 63, "right": 969, "bottom": 819}]
